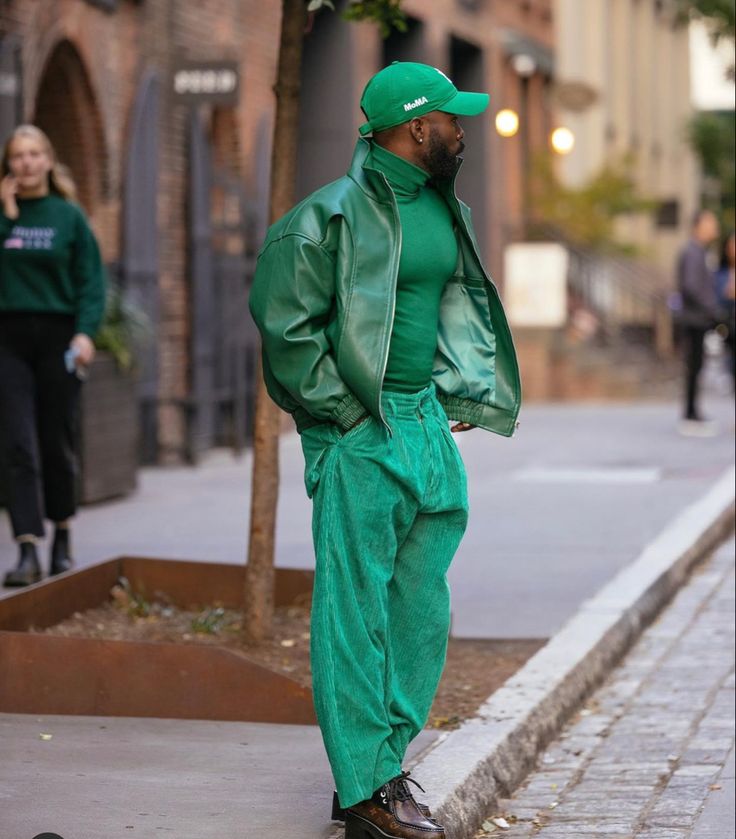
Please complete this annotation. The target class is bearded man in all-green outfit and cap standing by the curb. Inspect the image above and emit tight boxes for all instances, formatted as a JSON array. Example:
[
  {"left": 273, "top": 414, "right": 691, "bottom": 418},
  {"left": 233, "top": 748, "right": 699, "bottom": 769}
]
[{"left": 250, "top": 62, "right": 521, "bottom": 839}]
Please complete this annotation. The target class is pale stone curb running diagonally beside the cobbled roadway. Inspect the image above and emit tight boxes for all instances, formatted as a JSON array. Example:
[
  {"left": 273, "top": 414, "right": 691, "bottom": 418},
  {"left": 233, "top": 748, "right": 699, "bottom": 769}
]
[{"left": 413, "top": 467, "right": 735, "bottom": 839}]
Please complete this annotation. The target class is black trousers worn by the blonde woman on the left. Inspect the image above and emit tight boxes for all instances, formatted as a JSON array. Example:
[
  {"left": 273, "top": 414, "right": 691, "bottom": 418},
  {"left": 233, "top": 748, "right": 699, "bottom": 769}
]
[{"left": 0, "top": 312, "right": 81, "bottom": 538}]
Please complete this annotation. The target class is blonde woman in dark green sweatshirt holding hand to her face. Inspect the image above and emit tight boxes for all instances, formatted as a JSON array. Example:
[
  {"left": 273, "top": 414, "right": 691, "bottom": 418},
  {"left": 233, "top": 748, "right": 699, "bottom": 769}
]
[{"left": 0, "top": 125, "right": 105, "bottom": 586}]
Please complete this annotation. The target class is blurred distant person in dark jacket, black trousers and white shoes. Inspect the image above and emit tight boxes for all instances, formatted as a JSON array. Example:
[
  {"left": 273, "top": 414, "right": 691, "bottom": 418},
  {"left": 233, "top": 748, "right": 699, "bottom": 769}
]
[{"left": 677, "top": 210, "right": 720, "bottom": 436}]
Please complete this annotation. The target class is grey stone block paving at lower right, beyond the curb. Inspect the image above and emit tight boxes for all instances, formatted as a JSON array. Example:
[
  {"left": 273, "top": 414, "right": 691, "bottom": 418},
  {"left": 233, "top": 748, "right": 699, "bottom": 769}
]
[{"left": 478, "top": 540, "right": 735, "bottom": 839}]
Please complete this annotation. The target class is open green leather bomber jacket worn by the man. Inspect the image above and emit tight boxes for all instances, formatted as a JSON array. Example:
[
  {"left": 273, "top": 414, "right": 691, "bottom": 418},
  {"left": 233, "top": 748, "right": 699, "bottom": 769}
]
[{"left": 250, "top": 140, "right": 521, "bottom": 437}]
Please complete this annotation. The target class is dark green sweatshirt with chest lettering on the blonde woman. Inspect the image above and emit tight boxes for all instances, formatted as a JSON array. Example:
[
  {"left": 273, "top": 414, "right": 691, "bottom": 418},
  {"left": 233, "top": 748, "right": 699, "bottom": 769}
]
[{"left": 0, "top": 194, "right": 105, "bottom": 337}]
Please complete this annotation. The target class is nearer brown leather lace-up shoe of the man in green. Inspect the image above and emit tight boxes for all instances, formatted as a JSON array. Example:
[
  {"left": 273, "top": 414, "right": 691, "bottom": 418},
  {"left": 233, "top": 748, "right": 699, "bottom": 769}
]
[{"left": 345, "top": 772, "right": 445, "bottom": 839}]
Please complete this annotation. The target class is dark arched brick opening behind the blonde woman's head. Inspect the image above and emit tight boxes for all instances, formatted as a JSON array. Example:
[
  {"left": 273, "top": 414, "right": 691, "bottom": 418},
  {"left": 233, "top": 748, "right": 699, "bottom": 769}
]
[{"left": 33, "top": 41, "right": 108, "bottom": 215}]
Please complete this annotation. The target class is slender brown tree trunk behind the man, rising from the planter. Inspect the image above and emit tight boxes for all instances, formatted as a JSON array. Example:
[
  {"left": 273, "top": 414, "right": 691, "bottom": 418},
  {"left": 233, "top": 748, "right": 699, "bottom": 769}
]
[{"left": 244, "top": 0, "right": 307, "bottom": 641}]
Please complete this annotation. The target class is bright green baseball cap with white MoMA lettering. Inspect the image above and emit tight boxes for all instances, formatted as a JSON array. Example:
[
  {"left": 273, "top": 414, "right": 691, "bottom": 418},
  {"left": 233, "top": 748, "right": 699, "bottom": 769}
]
[{"left": 360, "top": 61, "right": 489, "bottom": 135}]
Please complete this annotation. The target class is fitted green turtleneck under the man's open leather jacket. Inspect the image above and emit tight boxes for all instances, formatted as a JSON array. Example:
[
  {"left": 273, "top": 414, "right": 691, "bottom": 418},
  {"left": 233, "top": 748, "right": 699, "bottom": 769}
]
[{"left": 366, "top": 143, "right": 458, "bottom": 393}]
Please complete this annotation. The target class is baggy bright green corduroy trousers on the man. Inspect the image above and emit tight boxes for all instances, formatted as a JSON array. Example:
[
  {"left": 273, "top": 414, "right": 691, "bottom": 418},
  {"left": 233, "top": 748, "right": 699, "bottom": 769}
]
[{"left": 302, "top": 387, "right": 468, "bottom": 807}]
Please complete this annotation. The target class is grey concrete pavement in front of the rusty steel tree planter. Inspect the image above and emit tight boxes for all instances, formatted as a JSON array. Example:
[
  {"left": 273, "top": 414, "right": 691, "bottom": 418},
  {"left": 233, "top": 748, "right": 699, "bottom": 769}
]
[{"left": 0, "top": 714, "right": 436, "bottom": 839}]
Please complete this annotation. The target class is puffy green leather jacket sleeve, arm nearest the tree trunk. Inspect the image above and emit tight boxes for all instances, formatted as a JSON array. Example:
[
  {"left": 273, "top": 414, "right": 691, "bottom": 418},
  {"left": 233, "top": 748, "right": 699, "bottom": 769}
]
[{"left": 250, "top": 234, "right": 367, "bottom": 429}]
